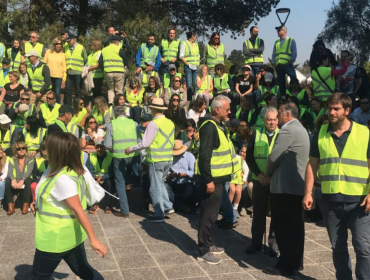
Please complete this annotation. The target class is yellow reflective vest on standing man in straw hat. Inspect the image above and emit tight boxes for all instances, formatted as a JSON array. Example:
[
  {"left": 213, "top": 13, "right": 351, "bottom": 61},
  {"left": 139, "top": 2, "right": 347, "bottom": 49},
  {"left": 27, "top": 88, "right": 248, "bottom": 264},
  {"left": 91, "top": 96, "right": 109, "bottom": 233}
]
[{"left": 146, "top": 116, "right": 175, "bottom": 163}]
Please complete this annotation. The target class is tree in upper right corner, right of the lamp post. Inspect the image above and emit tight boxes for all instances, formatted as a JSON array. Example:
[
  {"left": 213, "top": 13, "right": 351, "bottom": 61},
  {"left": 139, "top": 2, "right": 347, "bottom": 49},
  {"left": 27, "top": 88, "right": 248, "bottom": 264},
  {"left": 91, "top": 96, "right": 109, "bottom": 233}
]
[{"left": 319, "top": 0, "right": 370, "bottom": 64}]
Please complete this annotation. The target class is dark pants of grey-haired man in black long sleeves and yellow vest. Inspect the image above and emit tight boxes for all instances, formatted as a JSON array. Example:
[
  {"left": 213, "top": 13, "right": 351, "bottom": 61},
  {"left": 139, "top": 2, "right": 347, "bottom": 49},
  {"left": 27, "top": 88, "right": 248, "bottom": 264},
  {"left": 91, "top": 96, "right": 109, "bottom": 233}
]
[{"left": 198, "top": 183, "right": 225, "bottom": 256}]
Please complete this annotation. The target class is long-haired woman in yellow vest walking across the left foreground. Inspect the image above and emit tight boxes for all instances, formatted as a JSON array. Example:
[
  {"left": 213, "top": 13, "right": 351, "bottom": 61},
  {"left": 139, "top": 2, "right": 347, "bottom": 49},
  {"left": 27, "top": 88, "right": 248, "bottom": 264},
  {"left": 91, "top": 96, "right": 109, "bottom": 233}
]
[{"left": 31, "top": 132, "right": 107, "bottom": 280}]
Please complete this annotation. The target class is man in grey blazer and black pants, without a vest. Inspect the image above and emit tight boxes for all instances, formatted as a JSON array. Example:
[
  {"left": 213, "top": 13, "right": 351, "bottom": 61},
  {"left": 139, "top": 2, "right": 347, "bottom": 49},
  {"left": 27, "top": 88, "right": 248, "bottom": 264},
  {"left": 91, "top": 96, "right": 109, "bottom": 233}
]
[{"left": 263, "top": 102, "right": 310, "bottom": 276}]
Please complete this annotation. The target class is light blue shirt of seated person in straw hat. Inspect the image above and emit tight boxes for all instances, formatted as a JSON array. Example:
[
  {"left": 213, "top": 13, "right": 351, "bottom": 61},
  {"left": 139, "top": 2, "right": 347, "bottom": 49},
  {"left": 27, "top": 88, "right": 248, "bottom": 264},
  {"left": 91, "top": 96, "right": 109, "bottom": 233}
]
[{"left": 169, "top": 152, "right": 195, "bottom": 185}]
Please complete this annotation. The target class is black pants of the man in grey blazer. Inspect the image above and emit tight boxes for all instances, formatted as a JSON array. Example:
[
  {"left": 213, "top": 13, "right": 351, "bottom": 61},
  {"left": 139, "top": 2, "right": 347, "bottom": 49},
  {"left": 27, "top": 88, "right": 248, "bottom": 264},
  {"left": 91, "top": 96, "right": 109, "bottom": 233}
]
[{"left": 270, "top": 194, "right": 304, "bottom": 272}]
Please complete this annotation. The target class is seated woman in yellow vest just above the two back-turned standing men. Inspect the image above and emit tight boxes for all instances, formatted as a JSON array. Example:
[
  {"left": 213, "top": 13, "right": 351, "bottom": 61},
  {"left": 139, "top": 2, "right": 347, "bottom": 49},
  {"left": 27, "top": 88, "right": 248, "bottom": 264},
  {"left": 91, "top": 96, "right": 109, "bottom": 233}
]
[{"left": 126, "top": 77, "right": 144, "bottom": 123}]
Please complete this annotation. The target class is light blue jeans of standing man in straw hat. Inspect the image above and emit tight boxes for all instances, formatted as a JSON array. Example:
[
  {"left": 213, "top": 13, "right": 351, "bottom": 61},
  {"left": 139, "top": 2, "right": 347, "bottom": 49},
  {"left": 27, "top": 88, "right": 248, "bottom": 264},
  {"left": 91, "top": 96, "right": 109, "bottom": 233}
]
[{"left": 148, "top": 160, "right": 172, "bottom": 218}]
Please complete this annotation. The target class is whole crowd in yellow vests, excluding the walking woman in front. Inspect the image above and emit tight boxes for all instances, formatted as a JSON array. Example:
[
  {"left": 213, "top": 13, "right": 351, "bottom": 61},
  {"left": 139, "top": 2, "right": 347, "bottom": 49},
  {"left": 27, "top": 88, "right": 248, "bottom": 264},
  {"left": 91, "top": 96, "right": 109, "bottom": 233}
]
[{"left": 0, "top": 26, "right": 370, "bottom": 279}]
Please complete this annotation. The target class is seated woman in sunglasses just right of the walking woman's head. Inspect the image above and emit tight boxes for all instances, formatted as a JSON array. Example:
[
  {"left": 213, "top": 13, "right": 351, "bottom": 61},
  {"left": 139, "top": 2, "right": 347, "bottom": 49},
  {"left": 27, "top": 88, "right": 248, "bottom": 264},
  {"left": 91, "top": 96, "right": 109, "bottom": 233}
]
[{"left": 81, "top": 116, "right": 104, "bottom": 154}]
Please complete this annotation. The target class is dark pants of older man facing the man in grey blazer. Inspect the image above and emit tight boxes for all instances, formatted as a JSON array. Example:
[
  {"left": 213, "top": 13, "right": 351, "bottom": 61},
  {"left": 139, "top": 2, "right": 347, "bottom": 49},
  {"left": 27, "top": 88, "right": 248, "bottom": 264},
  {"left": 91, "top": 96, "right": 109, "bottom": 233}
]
[{"left": 252, "top": 179, "right": 277, "bottom": 250}]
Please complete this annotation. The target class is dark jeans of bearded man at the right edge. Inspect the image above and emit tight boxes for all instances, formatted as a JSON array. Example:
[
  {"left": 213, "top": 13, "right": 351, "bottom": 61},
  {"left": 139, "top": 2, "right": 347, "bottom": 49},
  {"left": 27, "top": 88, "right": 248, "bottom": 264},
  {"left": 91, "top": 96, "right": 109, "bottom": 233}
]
[{"left": 322, "top": 199, "right": 370, "bottom": 280}]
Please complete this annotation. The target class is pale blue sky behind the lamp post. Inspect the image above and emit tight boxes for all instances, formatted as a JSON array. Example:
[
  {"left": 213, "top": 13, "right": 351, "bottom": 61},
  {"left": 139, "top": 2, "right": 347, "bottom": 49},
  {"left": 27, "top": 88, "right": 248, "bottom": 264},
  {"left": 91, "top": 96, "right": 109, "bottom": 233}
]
[{"left": 181, "top": 0, "right": 337, "bottom": 63}]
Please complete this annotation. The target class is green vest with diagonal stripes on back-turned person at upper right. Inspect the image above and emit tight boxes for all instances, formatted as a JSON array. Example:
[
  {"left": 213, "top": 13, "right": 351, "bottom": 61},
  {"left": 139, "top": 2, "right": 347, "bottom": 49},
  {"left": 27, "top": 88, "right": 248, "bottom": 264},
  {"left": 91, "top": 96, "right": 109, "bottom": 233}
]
[{"left": 311, "top": 66, "right": 335, "bottom": 101}]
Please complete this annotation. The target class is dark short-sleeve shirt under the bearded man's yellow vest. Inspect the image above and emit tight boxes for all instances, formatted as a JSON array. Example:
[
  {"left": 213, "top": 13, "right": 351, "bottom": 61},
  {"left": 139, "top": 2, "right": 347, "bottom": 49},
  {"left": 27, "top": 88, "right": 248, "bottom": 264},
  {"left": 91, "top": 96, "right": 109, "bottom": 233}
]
[{"left": 310, "top": 121, "right": 370, "bottom": 203}]
